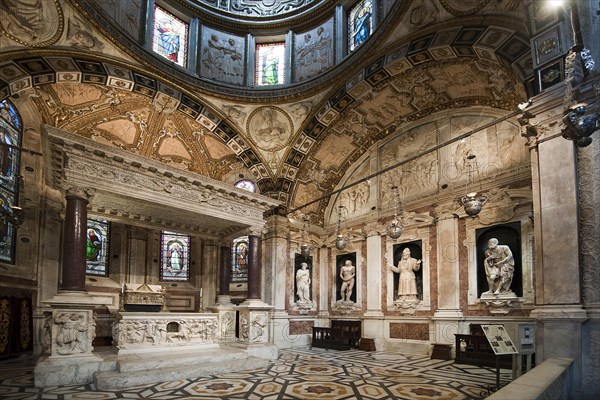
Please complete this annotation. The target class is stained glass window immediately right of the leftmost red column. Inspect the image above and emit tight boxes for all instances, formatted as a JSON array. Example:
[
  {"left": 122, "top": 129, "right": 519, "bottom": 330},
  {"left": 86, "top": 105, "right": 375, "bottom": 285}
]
[{"left": 85, "top": 218, "right": 110, "bottom": 276}]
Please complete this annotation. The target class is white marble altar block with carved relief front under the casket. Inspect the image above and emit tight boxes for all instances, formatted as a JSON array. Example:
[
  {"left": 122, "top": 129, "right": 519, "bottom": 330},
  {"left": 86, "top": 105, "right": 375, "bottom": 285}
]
[{"left": 113, "top": 312, "right": 219, "bottom": 355}]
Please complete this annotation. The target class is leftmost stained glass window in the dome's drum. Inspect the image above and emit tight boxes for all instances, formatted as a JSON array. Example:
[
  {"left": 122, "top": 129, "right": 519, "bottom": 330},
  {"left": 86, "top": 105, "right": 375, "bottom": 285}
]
[{"left": 152, "top": 6, "right": 188, "bottom": 67}]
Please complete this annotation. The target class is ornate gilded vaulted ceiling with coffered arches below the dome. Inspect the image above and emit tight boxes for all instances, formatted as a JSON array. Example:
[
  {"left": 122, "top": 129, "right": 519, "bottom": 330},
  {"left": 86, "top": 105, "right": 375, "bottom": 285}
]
[{"left": 0, "top": 0, "right": 531, "bottom": 225}]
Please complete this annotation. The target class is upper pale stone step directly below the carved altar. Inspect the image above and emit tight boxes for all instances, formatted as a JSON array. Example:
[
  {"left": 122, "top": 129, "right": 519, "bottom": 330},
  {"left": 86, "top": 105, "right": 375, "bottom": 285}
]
[{"left": 117, "top": 349, "right": 248, "bottom": 372}]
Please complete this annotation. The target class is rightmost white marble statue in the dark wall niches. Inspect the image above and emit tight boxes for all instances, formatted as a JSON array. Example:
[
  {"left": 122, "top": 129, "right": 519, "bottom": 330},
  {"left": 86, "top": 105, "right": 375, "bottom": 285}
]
[{"left": 483, "top": 238, "right": 515, "bottom": 294}]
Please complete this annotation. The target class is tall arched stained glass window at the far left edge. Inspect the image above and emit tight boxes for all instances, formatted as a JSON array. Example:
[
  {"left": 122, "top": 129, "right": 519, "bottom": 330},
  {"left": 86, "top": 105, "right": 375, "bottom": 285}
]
[{"left": 0, "top": 100, "right": 23, "bottom": 264}]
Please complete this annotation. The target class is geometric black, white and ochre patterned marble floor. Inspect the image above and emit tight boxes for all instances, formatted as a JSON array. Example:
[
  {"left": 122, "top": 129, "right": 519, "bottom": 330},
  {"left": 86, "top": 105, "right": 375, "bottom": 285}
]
[{"left": 0, "top": 349, "right": 510, "bottom": 400}]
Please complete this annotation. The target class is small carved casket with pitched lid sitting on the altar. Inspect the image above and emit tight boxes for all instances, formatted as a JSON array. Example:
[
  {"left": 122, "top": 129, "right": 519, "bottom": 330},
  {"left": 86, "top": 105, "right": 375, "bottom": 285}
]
[{"left": 120, "top": 283, "right": 167, "bottom": 312}]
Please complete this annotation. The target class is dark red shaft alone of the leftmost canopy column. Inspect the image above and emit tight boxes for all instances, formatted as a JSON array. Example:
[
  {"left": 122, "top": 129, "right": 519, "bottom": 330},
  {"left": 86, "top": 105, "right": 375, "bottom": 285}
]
[{"left": 61, "top": 194, "right": 88, "bottom": 291}]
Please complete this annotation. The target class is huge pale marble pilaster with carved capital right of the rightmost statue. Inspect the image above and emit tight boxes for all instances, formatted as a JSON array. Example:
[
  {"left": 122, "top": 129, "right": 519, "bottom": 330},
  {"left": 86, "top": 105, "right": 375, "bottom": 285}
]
[{"left": 529, "top": 87, "right": 594, "bottom": 398}]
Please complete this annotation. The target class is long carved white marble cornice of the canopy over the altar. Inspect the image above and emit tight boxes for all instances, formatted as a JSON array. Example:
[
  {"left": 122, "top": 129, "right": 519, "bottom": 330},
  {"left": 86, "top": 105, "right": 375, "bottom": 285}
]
[{"left": 42, "top": 126, "right": 279, "bottom": 238}]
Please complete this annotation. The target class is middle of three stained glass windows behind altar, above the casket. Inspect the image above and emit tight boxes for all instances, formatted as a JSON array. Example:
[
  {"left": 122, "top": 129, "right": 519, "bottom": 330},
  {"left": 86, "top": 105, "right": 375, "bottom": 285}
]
[{"left": 160, "top": 231, "right": 191, "bottom": 282}]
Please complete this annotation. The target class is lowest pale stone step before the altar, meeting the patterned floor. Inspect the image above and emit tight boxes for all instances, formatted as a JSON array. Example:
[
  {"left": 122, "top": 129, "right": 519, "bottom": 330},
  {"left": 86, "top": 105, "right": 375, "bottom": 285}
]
[{"left": 94, "top": 357, "right": 270, "bottom": 390}]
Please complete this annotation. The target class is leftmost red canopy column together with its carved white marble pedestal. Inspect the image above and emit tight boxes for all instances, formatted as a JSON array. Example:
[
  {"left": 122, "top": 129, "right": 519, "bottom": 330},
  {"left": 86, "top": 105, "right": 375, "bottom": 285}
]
[{"left": 34, "top": 187, "right": 112, "bottom": 387}]
